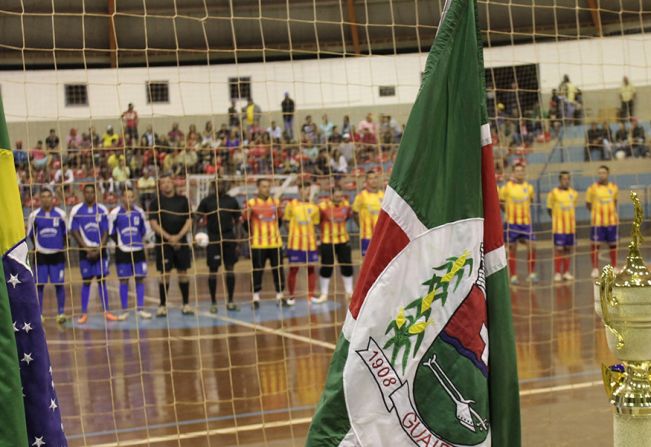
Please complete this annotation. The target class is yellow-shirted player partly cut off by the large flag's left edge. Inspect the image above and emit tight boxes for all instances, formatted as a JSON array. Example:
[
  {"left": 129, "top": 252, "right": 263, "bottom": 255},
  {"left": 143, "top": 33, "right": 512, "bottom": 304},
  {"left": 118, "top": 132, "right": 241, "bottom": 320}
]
[{"left": 353, "top": 171, "right": 384, "bottom": 256}]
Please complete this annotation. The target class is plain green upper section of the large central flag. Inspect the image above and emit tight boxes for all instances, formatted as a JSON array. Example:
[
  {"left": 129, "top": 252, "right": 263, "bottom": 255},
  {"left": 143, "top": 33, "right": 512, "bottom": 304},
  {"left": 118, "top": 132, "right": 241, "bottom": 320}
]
[{"left": 389, "top": 0, "right": 485, "bottom": 228}]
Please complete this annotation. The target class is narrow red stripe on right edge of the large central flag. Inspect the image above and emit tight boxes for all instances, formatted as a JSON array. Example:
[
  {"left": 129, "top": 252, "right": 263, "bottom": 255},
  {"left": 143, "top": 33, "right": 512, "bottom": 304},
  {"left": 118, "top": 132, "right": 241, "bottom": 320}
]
[{"left": 481, "top": 144, "right": 504, "bottom": 253}]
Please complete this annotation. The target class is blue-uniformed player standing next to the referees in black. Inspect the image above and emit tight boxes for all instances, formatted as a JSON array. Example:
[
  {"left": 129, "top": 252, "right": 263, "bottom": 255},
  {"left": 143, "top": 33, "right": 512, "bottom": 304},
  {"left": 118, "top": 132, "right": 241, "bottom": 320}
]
[{"left": 109, "top": 188, "right": 151, "bottom": 320}]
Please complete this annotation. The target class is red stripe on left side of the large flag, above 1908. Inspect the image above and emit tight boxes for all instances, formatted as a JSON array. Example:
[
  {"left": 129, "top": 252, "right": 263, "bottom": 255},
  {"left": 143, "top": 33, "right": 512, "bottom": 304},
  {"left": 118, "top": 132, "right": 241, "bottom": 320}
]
[{"left": 349, "top": 210, "right": 409, "bottom": 319}]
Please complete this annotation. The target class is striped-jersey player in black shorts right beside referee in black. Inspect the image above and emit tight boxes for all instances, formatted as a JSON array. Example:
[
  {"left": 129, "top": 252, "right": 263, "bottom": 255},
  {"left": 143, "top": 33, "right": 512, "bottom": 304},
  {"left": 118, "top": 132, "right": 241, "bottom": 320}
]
[{"left": 244, "top": 178, "right": 286, "bottom": 309}]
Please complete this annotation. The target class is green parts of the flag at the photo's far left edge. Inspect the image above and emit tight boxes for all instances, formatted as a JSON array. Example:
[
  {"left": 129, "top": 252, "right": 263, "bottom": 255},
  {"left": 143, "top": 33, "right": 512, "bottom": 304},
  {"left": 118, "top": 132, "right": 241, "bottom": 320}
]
[{"left": 0, "top": 93, "right": 28, "bottom": 447}]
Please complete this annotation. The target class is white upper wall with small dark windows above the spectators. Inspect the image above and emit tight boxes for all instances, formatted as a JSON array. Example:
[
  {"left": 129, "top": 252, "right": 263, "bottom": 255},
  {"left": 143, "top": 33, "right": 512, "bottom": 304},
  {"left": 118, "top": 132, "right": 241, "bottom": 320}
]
[{"left": 0, "top": 35, "right": 651, "bottom": 122}]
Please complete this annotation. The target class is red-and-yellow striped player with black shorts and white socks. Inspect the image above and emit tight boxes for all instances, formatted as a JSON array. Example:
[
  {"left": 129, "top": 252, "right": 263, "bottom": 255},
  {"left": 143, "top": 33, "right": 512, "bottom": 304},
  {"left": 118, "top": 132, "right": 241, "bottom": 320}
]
[{"left": 318, "top": 186, "right": 353, "bottom": 302}]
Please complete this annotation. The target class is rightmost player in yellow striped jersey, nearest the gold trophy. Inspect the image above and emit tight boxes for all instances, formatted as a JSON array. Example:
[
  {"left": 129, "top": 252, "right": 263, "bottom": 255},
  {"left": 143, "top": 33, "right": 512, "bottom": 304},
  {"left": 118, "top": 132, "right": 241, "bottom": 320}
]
[{"left": 585, "top": 166, "right": 619, "bottom": 278}]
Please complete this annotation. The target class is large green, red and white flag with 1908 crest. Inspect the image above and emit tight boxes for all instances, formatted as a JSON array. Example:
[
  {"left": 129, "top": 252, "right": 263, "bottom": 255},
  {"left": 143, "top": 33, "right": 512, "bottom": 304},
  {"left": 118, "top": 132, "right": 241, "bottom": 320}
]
[{"left": 306, "top": 0, "right": 520, "bottom": 447}]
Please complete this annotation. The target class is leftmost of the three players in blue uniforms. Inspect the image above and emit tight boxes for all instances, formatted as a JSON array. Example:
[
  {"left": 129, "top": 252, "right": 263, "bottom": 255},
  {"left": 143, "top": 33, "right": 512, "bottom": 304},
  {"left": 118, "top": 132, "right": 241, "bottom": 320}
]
[{"left": 27, "top": 188, "right": 67, "bottom": 324}]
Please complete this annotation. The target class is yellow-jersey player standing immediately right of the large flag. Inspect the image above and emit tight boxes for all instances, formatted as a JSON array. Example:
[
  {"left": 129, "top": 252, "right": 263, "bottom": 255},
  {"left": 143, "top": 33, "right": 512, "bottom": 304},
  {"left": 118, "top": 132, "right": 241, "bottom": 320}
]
[{"left": 500, "top": 164, "right": 538, "bottom": 284}]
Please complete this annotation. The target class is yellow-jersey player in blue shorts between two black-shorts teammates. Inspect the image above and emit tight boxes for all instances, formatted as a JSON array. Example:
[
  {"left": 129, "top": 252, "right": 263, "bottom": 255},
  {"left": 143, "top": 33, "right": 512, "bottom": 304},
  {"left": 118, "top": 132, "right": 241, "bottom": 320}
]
[{"left": 283, "top": 180, "right": 320, "bottom": 302}]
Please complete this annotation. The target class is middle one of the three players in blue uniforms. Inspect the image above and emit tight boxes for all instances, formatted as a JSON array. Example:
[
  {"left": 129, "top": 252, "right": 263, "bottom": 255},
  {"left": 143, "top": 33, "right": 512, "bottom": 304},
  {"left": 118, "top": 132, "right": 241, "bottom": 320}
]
[{"left": 70, "top": 184, "right": 118, "bottom": 324}]
